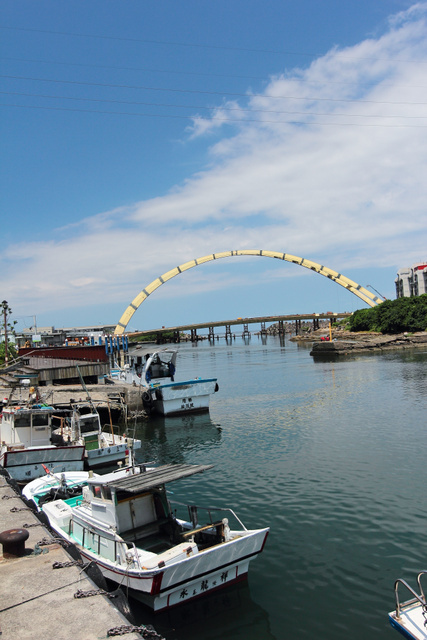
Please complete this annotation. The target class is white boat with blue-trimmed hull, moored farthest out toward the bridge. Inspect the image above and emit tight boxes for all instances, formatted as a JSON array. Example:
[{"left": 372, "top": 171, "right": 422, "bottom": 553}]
[{"left": 111, "top": 349, "right": 219, "bottom": 416}]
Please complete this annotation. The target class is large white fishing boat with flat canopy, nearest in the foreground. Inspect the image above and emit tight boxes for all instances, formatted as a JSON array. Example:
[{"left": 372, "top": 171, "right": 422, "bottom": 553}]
[{"left": 38, "top": 464, "right": 269, "bottom": 611}]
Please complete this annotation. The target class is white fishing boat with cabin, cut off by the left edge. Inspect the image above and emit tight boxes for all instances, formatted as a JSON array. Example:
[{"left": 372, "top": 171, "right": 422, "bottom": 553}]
[{"left": 0, "top": 405, "right": 85, "bottom": 482}]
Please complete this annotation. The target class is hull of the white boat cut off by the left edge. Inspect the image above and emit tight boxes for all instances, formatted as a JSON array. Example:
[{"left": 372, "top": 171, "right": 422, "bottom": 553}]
[{"left": 0, "top": 445, "right": 85, "bottom": 482}]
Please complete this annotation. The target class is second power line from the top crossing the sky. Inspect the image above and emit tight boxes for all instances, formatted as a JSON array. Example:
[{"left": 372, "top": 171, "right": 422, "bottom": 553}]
[{"left": 0, "top": 75, "right": 427, "bottom": 106}]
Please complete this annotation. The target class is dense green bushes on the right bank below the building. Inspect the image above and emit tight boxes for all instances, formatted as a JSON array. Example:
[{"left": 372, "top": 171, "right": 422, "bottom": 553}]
[{"left": 349, "top": 294, "right": 427, "bottom": 333}]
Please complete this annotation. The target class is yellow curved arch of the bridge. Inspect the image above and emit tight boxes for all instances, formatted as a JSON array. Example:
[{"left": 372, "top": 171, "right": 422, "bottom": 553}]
[{"left": 114, "top": 249, "right": 382, "bottom": 335}]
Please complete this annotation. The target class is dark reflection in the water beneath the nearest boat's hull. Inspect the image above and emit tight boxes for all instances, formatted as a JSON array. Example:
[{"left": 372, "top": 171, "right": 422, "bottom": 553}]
[{"left": 129, "top": 581, "right": 276, "bottom": 640}]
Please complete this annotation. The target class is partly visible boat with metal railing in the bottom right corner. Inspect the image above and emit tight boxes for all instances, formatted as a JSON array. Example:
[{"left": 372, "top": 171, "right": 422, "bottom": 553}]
[{"left": 388, "top": 570, "right": 427, "bottom": 640}]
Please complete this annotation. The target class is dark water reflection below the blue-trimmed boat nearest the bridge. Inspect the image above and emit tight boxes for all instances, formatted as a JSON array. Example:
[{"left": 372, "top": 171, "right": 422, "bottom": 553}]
[{"left": 136, "top": 412, "right": 221, "bottom": 464}]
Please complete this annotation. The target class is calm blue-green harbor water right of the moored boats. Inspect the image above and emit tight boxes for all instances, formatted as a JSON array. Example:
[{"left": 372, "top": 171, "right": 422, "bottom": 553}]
[{"left": 132, "top": 336, "right": 427, "bottom": 640}]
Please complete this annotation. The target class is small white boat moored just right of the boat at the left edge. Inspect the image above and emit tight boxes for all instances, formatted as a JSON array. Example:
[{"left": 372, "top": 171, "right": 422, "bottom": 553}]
[{"left": 55, "top": 405, "right": 141, "bottom": 469}]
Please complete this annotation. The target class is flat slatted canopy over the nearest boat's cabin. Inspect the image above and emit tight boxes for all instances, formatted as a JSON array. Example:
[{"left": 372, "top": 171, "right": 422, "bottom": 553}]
[{"left": 99, "top": 464, "right": 213, "bottom": 493}]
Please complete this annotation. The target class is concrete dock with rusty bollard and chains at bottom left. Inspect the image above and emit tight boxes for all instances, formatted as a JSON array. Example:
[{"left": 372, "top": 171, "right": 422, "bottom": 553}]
[{"left": 0, "top": 475, "right": 147, "bottom": 640}]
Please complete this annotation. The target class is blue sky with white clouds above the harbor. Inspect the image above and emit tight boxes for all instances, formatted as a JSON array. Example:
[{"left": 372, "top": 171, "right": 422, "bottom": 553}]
[{"left": 0, "top": 0, "right": 427, "bottom": 331}]
